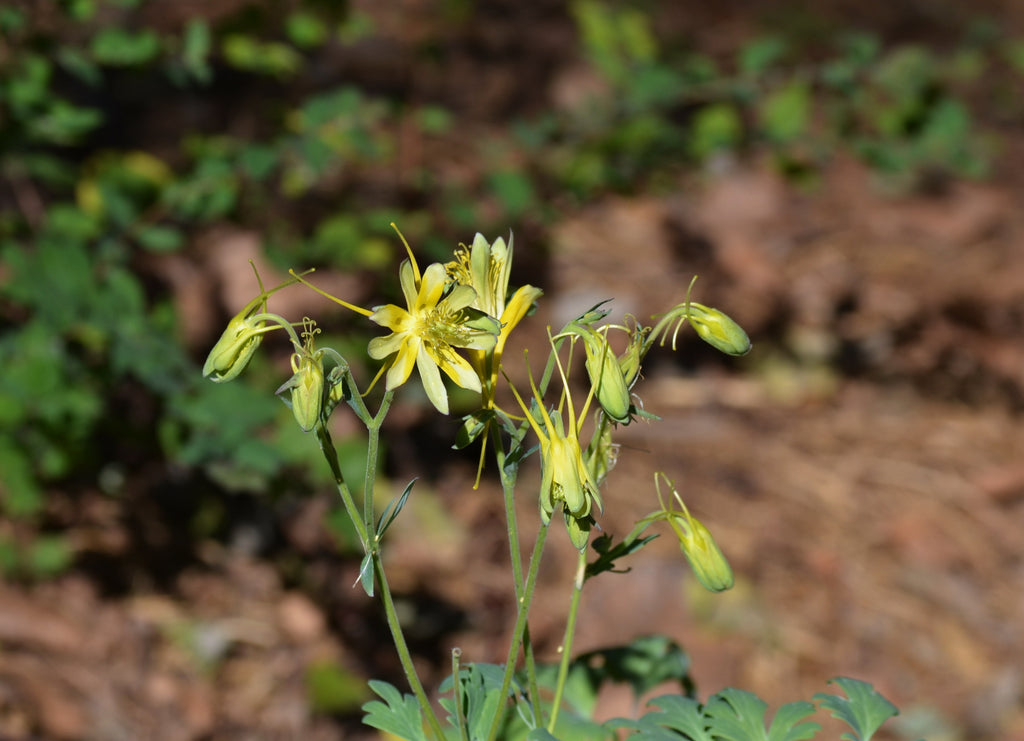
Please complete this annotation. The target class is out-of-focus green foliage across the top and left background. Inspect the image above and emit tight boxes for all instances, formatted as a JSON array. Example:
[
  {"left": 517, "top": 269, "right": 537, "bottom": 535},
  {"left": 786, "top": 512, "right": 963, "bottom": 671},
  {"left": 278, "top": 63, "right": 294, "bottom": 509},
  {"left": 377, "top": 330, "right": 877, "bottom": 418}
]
[{"left": 0, "top": 0, "right": 1024, "bottom": 575}]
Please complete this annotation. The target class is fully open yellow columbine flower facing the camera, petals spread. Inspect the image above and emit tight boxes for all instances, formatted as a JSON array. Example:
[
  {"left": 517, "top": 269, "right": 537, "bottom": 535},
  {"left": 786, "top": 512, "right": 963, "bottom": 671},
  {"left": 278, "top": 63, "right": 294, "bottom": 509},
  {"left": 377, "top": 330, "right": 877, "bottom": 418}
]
[{"left": 369, "top": 245, "right": 501, "bottom": 415}]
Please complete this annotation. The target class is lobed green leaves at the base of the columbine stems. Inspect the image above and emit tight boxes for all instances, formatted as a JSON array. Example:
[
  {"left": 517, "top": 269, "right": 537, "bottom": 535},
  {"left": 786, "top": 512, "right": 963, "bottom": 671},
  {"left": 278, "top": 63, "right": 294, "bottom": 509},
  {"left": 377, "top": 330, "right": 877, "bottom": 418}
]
[{"left": 362, "top": 637, "right": 898, "bottom": 741}]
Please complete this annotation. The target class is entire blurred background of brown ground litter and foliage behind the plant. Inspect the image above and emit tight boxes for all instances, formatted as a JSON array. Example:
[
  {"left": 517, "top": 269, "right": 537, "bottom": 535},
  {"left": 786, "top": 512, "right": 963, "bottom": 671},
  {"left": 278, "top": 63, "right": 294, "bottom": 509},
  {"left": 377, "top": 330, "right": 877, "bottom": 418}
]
[{"left": 0, "top": 0, "right": 1024, "bottom": 741}]
